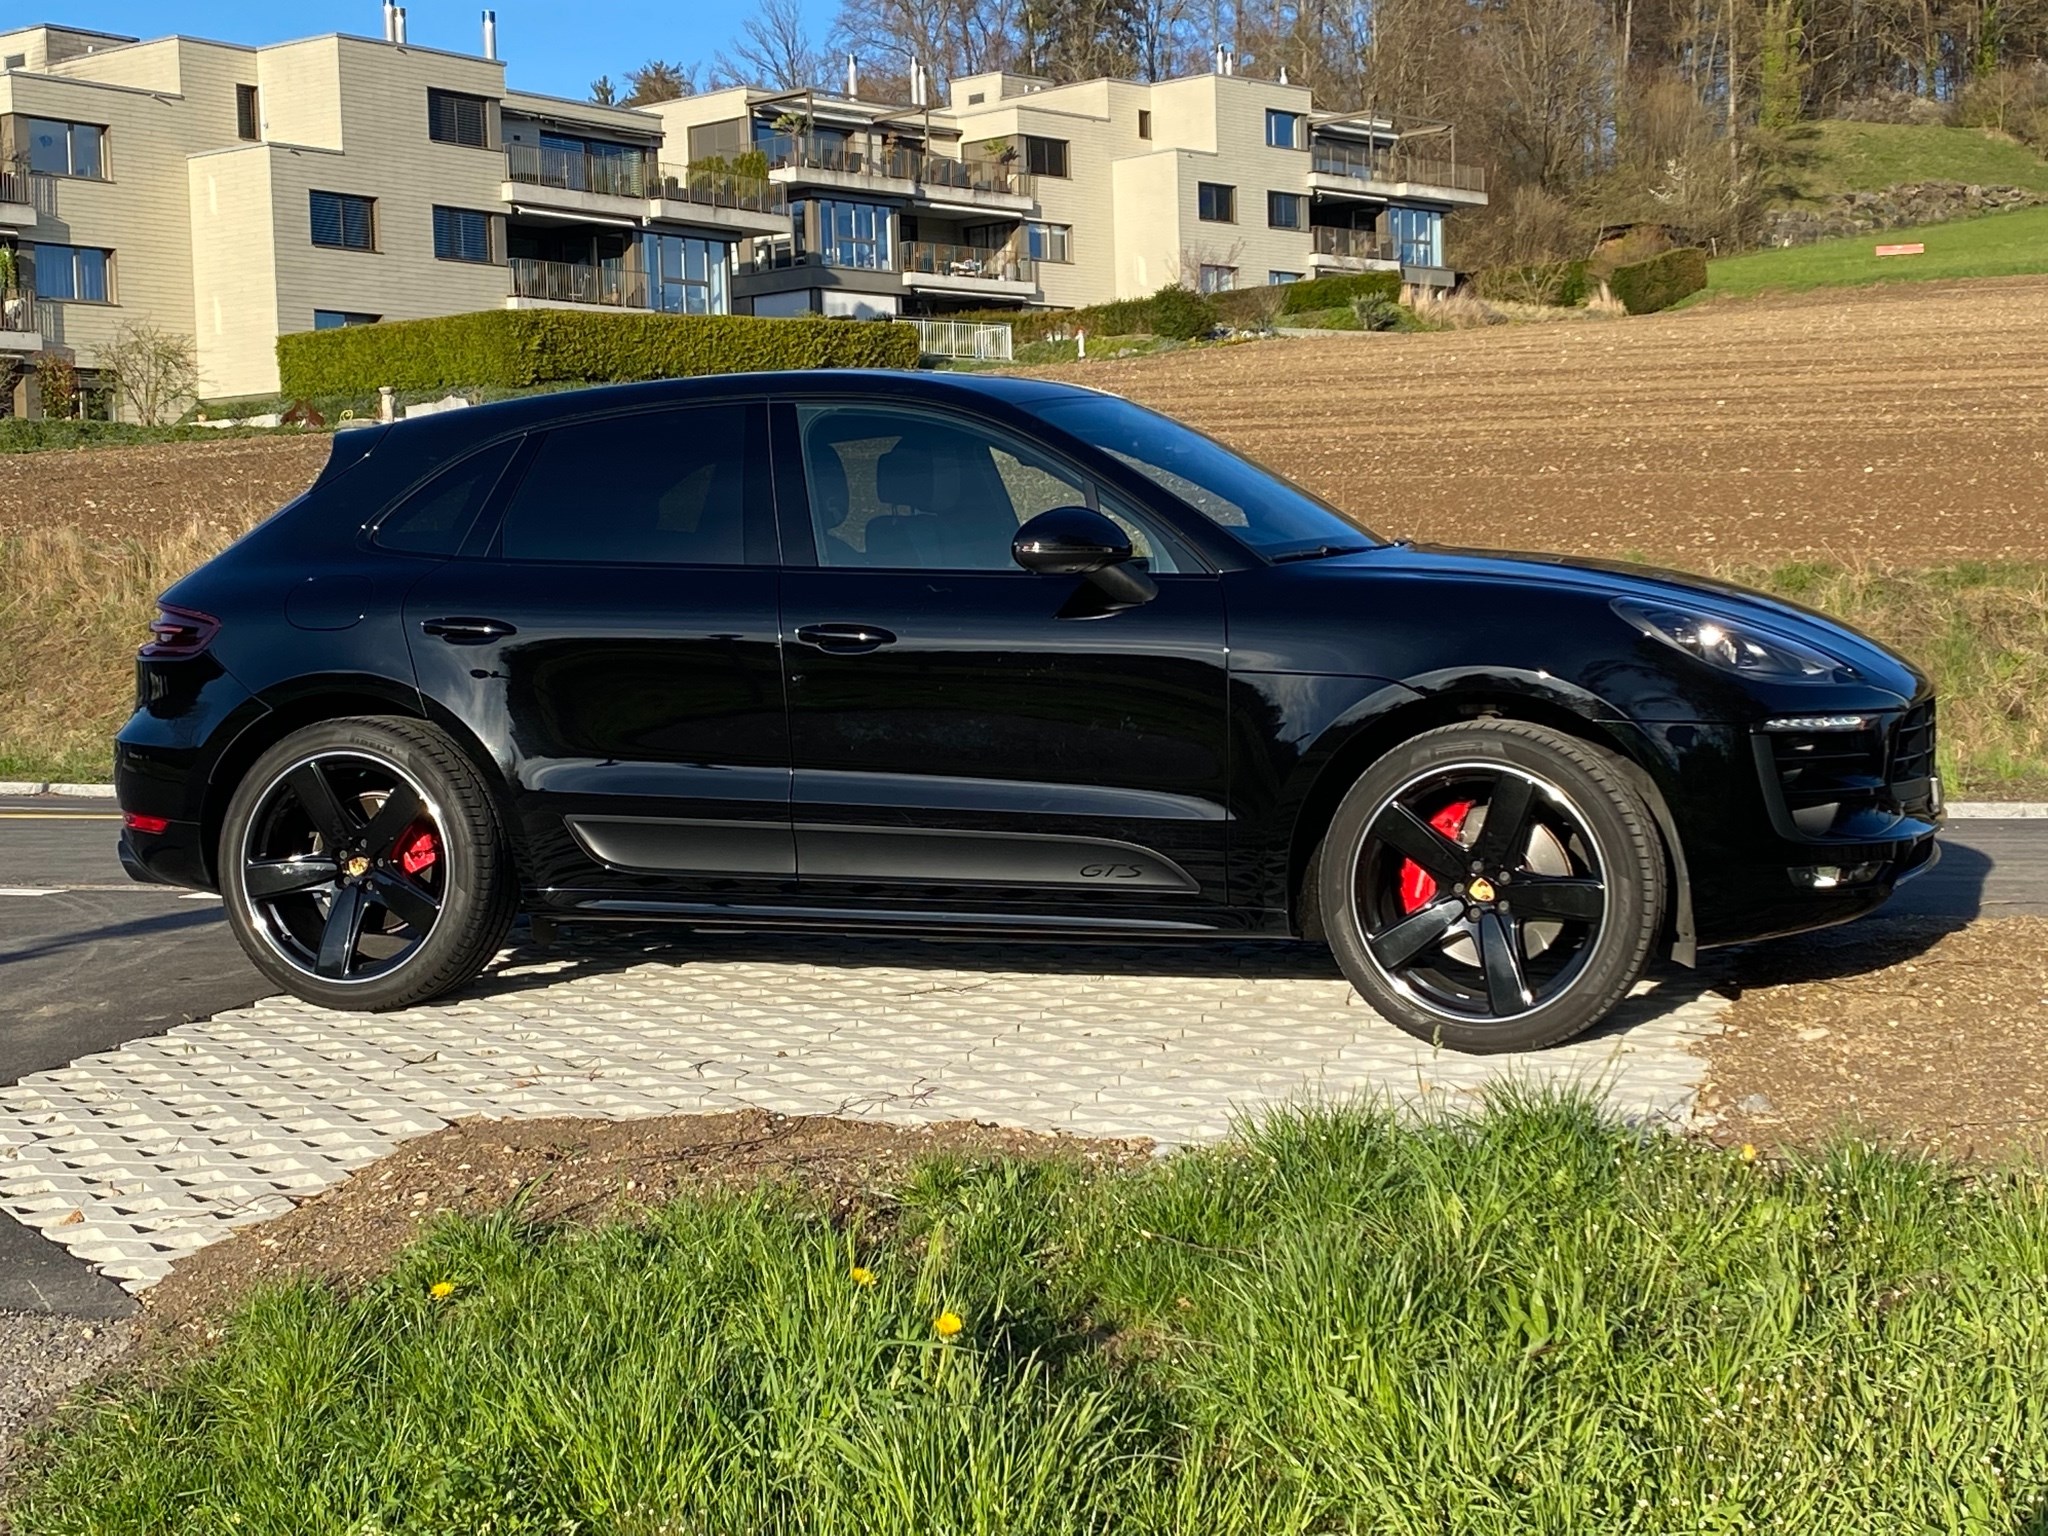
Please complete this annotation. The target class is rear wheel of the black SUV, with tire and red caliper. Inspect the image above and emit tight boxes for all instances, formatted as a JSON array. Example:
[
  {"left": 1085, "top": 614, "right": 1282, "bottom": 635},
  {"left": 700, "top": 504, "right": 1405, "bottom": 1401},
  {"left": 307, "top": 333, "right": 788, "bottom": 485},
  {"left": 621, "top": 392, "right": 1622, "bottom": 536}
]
[{"left": 219, "top": 717, "right": 518, "bottom": 1012}]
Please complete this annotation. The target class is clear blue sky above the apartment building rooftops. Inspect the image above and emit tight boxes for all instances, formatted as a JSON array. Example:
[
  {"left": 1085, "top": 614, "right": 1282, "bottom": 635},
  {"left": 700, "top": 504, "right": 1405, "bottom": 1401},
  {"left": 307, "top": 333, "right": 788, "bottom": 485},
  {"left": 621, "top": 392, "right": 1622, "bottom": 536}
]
[{"left": 41, "top": 0, "right": 834, "bottom": 96}]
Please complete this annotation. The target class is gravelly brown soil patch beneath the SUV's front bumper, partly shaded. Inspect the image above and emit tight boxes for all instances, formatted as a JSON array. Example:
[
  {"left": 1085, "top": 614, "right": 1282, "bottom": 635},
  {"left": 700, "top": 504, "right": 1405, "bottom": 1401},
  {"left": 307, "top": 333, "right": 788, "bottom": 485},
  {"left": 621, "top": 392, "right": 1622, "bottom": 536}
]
[{"left": 1702, "top": 918, "right": 2048, "bottom": 1159}]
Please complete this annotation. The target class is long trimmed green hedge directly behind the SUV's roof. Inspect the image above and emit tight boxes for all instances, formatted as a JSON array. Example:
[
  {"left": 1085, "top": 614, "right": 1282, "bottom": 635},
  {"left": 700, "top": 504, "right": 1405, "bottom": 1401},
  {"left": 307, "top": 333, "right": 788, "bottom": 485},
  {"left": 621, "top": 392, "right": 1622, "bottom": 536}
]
[{"left": 276, "top": 309, "right": 918, "bottom": 397}]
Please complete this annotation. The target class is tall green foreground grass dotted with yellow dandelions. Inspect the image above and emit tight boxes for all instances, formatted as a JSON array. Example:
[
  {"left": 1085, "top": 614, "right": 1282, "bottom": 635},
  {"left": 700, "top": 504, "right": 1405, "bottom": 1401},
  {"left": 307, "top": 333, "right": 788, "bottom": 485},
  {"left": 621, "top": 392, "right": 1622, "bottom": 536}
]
[{"left": 10, "top": 1100, "right": 2048, "bottom": 1536}]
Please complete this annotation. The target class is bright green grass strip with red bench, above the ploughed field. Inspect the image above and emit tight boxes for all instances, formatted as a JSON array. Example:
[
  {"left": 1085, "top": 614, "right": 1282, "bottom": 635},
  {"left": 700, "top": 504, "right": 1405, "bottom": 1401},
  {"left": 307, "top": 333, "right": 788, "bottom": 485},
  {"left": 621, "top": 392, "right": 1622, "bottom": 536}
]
[{"left": 1686, "top": 207, "right": 2048, "bottom": 303}]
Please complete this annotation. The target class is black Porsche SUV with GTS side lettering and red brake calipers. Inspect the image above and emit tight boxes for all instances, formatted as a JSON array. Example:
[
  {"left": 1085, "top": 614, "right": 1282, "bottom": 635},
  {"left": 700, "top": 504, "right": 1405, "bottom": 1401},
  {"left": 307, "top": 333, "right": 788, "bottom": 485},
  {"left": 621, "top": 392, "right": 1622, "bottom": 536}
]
[{"left": 117, "top": 373, "right": 1942, "bottom": 1051}]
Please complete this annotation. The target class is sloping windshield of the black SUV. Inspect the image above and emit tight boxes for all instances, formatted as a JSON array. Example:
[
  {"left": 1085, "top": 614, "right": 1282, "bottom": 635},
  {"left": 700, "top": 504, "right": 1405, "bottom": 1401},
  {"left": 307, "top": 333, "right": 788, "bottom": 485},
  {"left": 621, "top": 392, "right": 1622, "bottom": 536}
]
[{"left": 1038, "top": 395, "right": 1378, "bottom": 559}]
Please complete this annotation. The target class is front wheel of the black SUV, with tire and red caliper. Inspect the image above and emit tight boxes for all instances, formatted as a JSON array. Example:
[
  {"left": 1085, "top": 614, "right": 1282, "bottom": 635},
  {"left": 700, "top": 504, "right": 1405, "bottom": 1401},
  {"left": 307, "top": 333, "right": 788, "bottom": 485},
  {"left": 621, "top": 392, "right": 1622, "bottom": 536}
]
[{"left": 1311, "top": 721, "right": 1665, "bottom": 1055}]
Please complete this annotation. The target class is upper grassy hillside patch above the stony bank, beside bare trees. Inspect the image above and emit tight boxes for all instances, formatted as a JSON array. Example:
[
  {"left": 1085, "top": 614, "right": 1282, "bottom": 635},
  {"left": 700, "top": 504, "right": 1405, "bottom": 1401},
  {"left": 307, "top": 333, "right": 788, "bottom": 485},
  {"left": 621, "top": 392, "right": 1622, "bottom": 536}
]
[{"left": 1776, "top": 123, "right": 2048, "bottom": 203}]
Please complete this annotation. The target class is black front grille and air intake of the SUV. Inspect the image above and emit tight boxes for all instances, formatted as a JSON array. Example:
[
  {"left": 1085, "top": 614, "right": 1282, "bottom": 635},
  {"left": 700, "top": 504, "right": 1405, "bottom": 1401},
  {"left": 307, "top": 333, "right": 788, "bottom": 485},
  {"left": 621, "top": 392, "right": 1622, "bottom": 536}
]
[{"left": 1757, "top": 700, "right": 1933, "bottom": 838}]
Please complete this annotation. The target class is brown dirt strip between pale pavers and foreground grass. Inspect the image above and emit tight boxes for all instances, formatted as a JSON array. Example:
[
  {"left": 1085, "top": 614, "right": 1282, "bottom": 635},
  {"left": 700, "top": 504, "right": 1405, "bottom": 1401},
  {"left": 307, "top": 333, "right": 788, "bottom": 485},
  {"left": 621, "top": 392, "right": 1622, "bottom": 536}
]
[{"left": 143, "top": 1110, "right": 1151, "bottom": 1331}]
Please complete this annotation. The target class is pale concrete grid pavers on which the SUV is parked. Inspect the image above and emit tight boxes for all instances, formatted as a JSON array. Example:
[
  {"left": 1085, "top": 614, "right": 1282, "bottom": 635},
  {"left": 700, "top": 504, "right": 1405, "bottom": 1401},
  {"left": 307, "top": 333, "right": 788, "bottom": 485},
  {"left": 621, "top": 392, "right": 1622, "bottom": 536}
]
[{"left": 0, "top": 936, "right": 1726, "bottom": 1290}]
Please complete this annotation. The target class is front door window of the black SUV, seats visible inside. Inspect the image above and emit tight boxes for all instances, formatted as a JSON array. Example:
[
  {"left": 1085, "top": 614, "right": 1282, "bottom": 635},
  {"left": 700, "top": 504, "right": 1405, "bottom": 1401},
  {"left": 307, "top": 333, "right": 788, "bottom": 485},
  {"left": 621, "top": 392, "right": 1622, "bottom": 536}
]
[{"left": 797, "top": 406, "right": 1178, "bottom": 571}]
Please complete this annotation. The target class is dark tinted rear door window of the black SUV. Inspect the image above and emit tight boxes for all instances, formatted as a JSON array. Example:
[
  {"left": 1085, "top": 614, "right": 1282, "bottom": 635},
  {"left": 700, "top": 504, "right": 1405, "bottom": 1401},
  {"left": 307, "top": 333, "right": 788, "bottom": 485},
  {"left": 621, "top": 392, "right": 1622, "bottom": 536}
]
[{"left": 500, "top": 406, "right": 758, "bottom": 565}]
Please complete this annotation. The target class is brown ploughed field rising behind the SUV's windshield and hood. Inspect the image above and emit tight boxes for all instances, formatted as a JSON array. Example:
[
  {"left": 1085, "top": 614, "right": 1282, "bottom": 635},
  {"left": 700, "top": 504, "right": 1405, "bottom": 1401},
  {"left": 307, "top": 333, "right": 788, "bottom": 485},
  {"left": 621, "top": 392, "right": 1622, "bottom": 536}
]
[{"left": 1032, "top": 276, "right": 2048, "bottom": 567}]
